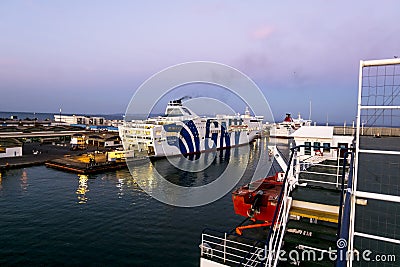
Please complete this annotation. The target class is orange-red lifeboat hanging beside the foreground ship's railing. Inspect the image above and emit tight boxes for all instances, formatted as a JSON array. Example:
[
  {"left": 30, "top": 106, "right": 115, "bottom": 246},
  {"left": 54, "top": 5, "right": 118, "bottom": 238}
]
[{"left": 232, "top": 174, "right": 282, "bottom": 222}]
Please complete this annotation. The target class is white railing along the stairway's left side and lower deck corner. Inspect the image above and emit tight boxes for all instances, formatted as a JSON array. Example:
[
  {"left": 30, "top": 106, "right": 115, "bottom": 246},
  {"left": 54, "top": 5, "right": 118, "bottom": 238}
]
[{"left": 200, "top": 145, "right": 353, "bottom": 267}]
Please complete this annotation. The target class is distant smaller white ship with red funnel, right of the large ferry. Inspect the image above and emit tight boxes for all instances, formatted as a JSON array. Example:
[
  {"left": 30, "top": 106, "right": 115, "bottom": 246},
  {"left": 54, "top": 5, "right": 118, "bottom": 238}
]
[{"left": 270, "top": 113, "right": 311, "bottom": 138}]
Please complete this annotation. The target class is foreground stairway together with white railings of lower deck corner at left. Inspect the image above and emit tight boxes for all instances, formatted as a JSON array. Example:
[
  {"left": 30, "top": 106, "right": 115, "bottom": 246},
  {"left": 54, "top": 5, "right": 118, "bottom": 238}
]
[{"left": 200, "top": 148, "right": 349, "bottom": 267}]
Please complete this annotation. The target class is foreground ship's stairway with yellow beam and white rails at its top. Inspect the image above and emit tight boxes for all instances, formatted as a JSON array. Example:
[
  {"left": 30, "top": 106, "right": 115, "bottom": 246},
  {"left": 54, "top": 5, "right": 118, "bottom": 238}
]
[{"left": 266, "top": 149, "right": 349, "bottom": 266}]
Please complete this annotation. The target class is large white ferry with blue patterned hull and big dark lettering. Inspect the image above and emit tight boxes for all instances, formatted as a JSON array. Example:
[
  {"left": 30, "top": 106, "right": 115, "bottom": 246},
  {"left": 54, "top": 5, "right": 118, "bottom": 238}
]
[{"left": 119, "top": 99, "right": 263, "bottom": 157}]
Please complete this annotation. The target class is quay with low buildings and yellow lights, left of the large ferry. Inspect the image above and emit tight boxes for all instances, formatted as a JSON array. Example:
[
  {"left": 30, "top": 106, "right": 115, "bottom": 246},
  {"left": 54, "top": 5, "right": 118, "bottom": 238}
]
[{"left": 0, "top": 124, "right": 152, "bottom": 174}]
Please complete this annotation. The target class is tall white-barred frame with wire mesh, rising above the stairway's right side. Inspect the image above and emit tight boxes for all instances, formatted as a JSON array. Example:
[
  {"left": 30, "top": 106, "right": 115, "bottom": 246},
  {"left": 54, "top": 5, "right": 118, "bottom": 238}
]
[{"left": 347, "top": 58, "right": 400, "bottom": 267}]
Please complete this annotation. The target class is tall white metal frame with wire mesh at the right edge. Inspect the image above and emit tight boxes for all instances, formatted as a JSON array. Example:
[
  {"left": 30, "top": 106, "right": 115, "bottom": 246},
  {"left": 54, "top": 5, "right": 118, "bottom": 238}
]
[{"left": 347, "top": 58, "right": 400, "bottom": 267}]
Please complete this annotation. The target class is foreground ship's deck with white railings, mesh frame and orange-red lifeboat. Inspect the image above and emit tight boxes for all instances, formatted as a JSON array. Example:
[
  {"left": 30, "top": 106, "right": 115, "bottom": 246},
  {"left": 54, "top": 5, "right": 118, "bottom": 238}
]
[{"left": 199, "top": 58, "right": 400, "bottom": 267}]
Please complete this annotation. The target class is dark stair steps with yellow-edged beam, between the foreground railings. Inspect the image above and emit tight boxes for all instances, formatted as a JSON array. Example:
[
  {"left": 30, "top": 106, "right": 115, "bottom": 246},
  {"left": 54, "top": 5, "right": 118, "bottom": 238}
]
[{"left": 278, "top": 187, "right": 341, "bottom": 266}]
